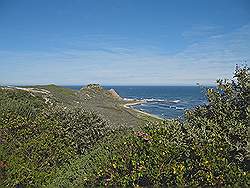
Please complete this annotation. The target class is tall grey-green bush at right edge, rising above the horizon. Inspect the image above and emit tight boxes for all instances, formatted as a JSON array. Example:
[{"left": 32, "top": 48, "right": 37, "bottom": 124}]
[{"left": 186, "top": 67, "right": 250, "bottom": 168}]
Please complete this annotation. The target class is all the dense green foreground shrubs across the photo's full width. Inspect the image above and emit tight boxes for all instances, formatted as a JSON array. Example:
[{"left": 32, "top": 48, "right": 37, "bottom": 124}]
[{"left": 0, "top": 67, "right": 250, "bottom": 187}]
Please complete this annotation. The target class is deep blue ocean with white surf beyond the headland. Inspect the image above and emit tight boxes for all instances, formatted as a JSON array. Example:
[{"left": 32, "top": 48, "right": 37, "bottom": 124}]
[{"left": 66, "top": 86, "right": 207, "bottom": 118}]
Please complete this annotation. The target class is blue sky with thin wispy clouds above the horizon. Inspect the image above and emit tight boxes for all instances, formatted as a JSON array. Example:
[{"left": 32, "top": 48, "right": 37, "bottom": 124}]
[{"left": 0, "top": 0, "right": 250, "bottom": 85}]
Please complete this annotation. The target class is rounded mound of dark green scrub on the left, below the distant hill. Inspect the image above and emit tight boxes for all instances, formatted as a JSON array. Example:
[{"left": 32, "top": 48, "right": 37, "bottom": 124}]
[{"left": 0, "top": 89, "right": 109, "bottom": 186}]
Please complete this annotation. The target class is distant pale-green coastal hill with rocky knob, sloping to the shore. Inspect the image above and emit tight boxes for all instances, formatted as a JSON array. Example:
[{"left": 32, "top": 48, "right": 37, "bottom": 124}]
[{"left": 1, "top": 84, "right": 157, "bottom": 127}]
